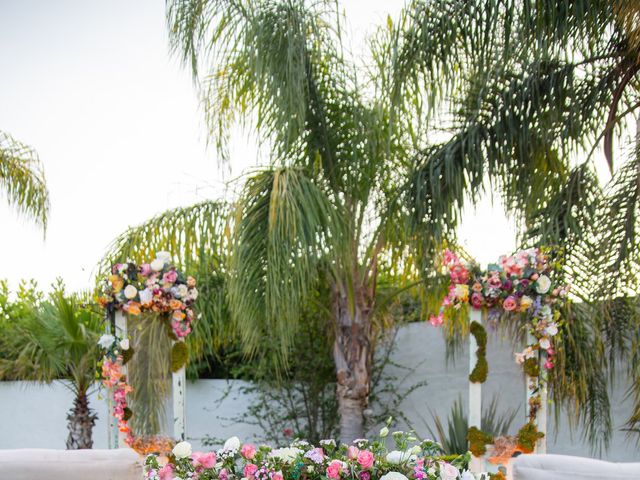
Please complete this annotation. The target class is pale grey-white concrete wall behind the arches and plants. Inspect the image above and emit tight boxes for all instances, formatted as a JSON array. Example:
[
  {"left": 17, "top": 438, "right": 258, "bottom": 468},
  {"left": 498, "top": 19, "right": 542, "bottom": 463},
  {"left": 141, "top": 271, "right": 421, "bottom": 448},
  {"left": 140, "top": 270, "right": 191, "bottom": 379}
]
[{"left": 0, "top": 323, "right": 640, "bottom": 461}]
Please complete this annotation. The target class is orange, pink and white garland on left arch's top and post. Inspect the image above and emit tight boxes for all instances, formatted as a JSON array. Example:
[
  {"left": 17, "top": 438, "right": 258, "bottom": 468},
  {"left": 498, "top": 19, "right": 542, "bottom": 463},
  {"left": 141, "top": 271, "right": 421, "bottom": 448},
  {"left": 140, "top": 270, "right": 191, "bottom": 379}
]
[{"left": 98, "top": 252, "right": 198, "bottom": 446}]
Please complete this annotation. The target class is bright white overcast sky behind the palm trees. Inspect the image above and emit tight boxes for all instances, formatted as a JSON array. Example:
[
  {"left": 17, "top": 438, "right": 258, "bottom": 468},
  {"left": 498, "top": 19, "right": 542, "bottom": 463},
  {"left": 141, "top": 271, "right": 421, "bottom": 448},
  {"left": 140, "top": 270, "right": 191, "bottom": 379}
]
[{"left": 0, "top": 0, "right": 515, "bottom": 290}]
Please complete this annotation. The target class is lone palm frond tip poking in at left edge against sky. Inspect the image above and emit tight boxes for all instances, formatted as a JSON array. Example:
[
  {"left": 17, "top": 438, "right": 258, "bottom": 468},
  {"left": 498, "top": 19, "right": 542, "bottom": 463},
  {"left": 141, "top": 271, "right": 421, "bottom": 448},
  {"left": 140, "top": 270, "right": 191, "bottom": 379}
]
[{"left": 0, "top": 132, "right": 49, "bottom": 228}]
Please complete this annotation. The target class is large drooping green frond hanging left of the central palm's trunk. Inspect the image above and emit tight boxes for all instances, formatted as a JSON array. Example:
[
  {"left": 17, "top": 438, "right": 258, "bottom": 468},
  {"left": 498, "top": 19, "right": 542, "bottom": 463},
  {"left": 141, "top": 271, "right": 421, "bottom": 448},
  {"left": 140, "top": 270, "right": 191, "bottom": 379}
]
[{"left": 229, "top": 169, "right": 343, "bottom": 368}]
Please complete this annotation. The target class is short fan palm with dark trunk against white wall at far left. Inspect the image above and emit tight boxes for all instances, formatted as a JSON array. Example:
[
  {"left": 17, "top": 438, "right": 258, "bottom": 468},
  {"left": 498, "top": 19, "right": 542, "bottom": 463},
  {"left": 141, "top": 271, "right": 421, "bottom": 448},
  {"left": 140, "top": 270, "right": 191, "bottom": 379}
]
[{"left": 0, "top": 289, "right": 103, "bottom": 449}]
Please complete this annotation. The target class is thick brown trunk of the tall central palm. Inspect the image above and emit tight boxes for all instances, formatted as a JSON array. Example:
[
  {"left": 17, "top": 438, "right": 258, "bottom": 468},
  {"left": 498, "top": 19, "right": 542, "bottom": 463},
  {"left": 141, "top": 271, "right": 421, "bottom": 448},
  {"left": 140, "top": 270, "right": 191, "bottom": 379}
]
[{"left": 332, "top": 287, "right": 373, "bottom": 443}]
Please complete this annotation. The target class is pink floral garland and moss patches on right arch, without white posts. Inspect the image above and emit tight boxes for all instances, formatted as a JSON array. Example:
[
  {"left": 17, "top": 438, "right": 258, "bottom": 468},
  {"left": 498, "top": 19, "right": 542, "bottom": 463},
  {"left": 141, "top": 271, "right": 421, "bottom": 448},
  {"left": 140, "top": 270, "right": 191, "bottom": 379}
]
[{"left": 429, "top": 248, "right": 569, "bottom": 452}]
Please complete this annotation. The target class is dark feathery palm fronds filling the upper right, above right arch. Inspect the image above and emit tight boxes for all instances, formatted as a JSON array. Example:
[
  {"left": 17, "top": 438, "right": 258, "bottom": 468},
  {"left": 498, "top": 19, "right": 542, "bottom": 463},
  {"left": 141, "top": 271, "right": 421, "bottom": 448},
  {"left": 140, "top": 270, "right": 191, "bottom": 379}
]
[{"left": 391, "top": 0, "right": 640, "bottom": 450}]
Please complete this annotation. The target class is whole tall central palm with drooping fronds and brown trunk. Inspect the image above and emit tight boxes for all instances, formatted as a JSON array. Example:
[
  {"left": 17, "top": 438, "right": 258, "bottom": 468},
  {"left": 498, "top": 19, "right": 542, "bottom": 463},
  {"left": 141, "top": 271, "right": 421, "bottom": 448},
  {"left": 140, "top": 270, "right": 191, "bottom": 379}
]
[{"left": 101, "top": 0, "right": 418, "bottom": 441}]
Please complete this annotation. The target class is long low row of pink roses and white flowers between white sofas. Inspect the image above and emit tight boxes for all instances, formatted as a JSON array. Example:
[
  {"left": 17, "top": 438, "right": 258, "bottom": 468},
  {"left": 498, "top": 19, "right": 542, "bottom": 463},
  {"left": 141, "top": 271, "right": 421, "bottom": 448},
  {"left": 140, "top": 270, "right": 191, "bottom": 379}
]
[{"left": 144, "top": 427, "right": 483, "bottom": 480}]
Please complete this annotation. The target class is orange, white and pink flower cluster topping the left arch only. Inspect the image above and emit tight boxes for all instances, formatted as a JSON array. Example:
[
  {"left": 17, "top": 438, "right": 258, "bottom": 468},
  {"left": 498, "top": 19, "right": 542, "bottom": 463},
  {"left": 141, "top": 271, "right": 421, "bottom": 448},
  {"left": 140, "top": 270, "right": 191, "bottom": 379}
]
[{"left": 98, "top": 252, "right": 198, "bottom": 338}]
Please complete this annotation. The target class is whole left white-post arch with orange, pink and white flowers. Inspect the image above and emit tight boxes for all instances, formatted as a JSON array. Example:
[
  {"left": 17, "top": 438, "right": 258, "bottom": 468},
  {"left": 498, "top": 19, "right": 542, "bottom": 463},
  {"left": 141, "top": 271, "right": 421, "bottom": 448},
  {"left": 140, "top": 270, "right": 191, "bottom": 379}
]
[{"left": 98, "top": 252, "right": 198, "bottom": 448}]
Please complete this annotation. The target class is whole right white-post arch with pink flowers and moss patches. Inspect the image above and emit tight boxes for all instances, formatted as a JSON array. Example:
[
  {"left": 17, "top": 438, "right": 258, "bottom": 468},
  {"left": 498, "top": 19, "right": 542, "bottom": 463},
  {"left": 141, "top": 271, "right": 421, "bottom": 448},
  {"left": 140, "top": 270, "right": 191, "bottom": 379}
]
[{"left": 429, "top": 248, "right": 569, "bottom": 472}]
